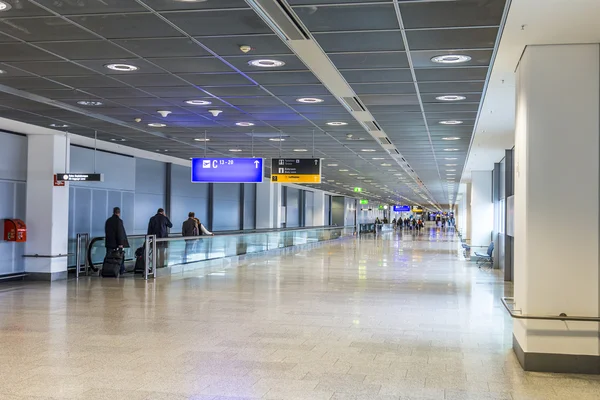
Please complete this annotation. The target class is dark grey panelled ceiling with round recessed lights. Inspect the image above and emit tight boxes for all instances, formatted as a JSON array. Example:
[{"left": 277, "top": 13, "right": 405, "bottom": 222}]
[{"left": 0, "top": 0, "right": 506, "bottom": 206}]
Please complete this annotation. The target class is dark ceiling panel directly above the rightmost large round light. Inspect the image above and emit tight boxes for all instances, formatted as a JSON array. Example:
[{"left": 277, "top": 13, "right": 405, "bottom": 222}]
[{"left": 406, "top": 28, "right": 498, "bottom": 50}]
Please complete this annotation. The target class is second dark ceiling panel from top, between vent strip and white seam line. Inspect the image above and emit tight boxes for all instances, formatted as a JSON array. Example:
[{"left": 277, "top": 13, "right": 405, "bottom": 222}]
[{"left": 314, "top": 30, "right": 404, "bottom": 53}]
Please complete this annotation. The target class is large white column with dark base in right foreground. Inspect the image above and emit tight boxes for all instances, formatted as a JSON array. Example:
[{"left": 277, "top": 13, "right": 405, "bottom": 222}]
[{"left": 514, "top": 44, "right": 600, "bottom": 373}]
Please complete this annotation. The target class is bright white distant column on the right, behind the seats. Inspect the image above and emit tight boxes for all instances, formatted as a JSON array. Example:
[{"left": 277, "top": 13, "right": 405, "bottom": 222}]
[{"left": 469, "top": 171, "right": 494, "bottom": 247}]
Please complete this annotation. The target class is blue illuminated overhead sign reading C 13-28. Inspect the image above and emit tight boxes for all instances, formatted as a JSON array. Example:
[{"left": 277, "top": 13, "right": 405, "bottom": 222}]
[{"left": 192, "top": 158, "right": 264, "bottom": 183}]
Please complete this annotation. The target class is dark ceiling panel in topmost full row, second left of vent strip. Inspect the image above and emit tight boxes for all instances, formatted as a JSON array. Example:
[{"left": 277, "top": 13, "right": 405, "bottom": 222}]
[{"left": 71, "top": 14, "right": 183, "bottom": 39}]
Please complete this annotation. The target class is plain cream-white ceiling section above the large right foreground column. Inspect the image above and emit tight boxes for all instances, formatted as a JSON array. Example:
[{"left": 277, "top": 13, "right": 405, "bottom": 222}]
[{"left": 463, "top": 0, "right": 600, "bottom": 182}]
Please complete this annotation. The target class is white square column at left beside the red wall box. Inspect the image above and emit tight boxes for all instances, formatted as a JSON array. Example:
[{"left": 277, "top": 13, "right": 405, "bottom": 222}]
[{"left": 25, "top": 135, "right": 69, "bottom": 280}]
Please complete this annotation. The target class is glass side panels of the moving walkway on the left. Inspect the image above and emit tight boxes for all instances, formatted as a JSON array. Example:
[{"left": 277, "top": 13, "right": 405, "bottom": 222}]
[{"left": 87, "top": 226, "right": 355, "bottom": 270}]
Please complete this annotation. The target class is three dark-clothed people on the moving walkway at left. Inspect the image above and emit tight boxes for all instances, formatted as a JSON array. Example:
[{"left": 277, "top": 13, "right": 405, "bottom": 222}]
[{"left": 104, "top": 207, "right": 214, "bottom": 274}]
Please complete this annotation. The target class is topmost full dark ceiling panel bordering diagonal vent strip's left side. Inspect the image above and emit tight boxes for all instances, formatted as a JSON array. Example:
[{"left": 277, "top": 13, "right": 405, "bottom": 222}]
[{"left": 164, "top": 9, "right": 273, "bottom": 36}]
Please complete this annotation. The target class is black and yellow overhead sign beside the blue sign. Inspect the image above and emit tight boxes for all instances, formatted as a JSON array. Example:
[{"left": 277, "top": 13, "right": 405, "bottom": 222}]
[{"left": 271, "top": 158, "right": 321, "bottom": 183}]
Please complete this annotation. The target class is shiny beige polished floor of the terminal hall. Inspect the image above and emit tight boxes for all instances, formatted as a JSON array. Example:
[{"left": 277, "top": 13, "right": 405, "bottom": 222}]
[{"left": 0, "top": 230, "right": 600, "bottom": 400}]
